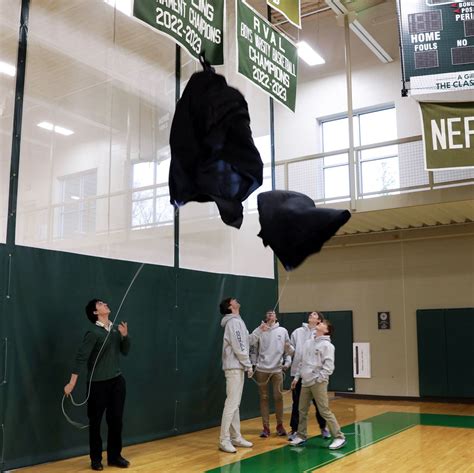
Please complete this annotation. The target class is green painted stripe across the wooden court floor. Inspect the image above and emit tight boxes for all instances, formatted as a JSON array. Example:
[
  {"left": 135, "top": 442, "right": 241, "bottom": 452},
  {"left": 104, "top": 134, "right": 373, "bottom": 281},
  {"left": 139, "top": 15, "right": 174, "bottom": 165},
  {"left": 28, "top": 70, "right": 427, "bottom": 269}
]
[{"left": 207, "top": 412, "right": 474, "bottom": 473}]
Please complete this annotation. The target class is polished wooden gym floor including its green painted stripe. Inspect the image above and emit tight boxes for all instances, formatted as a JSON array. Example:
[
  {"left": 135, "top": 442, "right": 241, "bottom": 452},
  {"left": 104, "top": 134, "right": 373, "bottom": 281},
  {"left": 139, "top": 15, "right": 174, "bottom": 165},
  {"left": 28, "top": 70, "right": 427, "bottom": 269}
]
[{"left": 12, "top": 398, "right": 474, "bottom": 473}]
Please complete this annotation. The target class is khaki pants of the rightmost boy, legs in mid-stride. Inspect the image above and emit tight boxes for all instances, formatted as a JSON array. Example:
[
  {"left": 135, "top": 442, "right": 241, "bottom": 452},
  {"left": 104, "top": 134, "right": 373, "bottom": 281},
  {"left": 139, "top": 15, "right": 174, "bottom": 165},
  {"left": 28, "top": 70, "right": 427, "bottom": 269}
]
[{"left": 298, "top": 381, "right": 344, "bottom": 439}]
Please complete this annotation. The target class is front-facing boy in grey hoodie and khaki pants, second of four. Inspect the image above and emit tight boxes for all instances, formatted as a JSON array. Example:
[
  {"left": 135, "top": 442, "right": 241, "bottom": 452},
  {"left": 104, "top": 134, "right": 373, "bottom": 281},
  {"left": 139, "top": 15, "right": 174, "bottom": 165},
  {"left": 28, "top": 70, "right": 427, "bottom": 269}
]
[{"left": 250, "top": 310, "right": 294, "bottom": 438}]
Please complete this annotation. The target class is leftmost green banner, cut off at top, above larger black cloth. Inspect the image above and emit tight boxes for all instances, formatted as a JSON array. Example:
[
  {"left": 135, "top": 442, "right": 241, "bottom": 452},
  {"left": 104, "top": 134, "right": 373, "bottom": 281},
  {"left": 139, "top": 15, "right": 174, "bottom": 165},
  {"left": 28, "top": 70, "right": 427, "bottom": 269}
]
[{"left": 133, "top": 0, "right": 225, "bottom": 65}]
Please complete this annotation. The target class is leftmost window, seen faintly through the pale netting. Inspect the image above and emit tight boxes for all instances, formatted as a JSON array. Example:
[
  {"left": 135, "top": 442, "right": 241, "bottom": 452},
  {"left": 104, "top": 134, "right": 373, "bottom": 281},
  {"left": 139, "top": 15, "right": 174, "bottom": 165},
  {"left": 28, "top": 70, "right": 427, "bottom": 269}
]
[{"left": 56, "top": 169, "right": 97, "bottom": 238}]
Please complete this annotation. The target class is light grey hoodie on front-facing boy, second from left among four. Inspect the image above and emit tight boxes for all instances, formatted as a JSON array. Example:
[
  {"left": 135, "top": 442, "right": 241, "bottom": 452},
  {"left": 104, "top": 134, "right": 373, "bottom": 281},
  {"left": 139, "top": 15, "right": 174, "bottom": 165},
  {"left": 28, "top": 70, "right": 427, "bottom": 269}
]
[{"left": 250, "top": 322, "right": 293, "bottom": 373}]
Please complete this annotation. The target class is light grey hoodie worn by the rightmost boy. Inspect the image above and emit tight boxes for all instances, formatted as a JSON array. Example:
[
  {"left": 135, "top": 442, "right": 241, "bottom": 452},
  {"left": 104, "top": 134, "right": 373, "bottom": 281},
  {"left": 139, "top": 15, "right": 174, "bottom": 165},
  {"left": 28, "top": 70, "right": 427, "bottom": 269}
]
[{"left": 295, "top": 335, "right": 335, "bottom": 387}]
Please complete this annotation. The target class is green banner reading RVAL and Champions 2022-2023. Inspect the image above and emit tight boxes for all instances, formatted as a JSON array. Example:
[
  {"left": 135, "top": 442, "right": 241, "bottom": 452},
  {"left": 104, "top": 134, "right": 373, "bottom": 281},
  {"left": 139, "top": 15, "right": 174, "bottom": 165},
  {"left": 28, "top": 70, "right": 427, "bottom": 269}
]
[{"left": 236, "top": 0, "right": 298, "bottom": 112}]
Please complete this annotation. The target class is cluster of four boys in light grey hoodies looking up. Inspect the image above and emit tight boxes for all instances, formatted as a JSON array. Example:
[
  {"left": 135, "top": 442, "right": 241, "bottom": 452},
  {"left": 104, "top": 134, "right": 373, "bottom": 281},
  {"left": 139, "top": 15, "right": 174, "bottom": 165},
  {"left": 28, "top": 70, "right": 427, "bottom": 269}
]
[{"left": 219, "top": 298, "right": 346, "bottom": 453}]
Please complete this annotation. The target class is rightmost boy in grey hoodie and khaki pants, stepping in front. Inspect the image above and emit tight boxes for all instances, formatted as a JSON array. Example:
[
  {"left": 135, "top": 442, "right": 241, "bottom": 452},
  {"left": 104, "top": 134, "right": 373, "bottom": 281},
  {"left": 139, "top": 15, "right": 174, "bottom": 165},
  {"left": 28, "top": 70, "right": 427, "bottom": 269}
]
[{"left": 290, "top": 320, "right": 346, "bottom": 450}]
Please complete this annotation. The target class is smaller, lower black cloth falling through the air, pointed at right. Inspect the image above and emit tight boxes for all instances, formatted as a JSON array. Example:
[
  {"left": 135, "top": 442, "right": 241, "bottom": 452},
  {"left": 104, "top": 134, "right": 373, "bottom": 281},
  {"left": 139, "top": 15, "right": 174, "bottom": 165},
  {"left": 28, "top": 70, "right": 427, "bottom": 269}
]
[{"left": 257, "top": 191, "right": 351, "bottom": 271}]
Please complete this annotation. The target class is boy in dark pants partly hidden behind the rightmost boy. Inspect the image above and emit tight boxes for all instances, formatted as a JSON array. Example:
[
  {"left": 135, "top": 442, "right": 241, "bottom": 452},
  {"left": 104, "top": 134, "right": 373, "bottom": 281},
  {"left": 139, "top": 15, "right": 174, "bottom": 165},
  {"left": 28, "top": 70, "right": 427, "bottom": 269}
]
[{"left": 288, "top": 311, "right": 331, "bottom": 440}]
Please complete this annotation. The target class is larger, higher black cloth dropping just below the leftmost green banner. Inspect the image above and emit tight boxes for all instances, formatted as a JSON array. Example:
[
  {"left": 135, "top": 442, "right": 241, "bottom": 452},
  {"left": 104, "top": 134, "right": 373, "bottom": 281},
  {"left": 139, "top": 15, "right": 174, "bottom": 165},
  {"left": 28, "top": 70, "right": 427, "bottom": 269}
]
[{"left": 169, "top": 59, "right": 263, "bottom": 228}]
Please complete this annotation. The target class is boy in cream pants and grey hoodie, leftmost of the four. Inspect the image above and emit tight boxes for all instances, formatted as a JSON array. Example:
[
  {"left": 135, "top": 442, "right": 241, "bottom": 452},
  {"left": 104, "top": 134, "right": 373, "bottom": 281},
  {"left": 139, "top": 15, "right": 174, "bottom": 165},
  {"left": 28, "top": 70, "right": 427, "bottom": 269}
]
[{"left": 219, "top": 297, "right": 254, "bottom": 453}]
